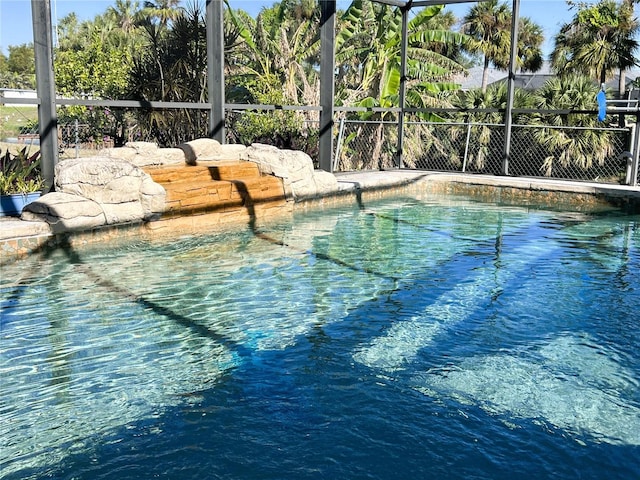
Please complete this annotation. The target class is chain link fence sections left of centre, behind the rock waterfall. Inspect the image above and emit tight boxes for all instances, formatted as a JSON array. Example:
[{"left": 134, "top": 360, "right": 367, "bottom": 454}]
[{"left": 0, "top": 104, "right": 320, "bottom": 156}]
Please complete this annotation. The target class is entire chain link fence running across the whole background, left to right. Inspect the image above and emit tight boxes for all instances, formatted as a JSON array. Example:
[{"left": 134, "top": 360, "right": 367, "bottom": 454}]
[{"left": 0, "top": 101, "right": 640, "bottom": 184}]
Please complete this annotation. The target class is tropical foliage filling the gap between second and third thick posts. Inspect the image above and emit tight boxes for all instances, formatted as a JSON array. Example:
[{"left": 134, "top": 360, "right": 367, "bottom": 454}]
[{"left": 225, "top": 0, "right": 320, "bottom": 156}]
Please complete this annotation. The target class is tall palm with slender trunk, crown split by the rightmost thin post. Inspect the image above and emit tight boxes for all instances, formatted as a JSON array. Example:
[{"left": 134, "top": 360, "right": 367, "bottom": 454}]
[{"left": 462, "top": 0, "right": 544, "bottom": 92}]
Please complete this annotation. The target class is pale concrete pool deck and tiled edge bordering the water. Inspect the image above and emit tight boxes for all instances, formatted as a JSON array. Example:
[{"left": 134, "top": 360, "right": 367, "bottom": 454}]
[{"left": 0, "top": 170, "right": 640, "bottom": 261}]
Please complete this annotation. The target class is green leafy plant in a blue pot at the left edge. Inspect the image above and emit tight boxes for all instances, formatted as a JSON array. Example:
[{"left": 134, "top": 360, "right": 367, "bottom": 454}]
[{"left": 0, "top": 147, "right": 44, "bottom": 216}]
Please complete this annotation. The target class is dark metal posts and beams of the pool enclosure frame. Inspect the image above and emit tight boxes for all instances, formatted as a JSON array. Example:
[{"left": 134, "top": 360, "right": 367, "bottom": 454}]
[{"left": 26, "top": 0, "right": 520, "bottom": 189}]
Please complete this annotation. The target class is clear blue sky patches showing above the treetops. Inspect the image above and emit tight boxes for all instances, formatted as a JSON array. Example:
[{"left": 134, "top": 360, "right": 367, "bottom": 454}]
[{"left": 0, "top": 0, "right": 592, "bottom": 55}]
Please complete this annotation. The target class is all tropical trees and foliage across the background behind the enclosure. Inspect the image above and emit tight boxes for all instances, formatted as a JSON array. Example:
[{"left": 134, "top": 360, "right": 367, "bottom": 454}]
[{"left": 0, "top": 0, "right": 638, "bottom": 180}]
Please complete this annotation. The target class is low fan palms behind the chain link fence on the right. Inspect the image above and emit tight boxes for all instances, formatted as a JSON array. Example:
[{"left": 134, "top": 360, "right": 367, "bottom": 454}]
[{"left": 416, "top": 75, "right": 615, "bottom": 178}]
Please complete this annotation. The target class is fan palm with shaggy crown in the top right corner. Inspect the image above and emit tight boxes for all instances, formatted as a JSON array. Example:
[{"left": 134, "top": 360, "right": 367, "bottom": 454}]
[{"left": 551, "top": 0, "right": 640, "bottom": 96}]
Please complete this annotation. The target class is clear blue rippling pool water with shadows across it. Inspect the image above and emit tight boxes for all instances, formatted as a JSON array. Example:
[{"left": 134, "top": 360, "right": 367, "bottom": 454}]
[{"left": 0, "top": 196, "right": 640, "bottom": 480}]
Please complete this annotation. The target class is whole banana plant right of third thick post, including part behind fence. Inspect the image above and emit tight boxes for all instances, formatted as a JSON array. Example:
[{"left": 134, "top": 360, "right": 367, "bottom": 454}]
[{"left": 336, "top": 0, "right": 467, "bottom": 168}]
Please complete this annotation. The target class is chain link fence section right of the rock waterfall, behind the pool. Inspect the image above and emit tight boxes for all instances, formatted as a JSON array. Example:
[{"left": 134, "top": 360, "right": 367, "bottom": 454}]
[{"left": 334, "top": 120, "right": 632, "bottom": 184}]
